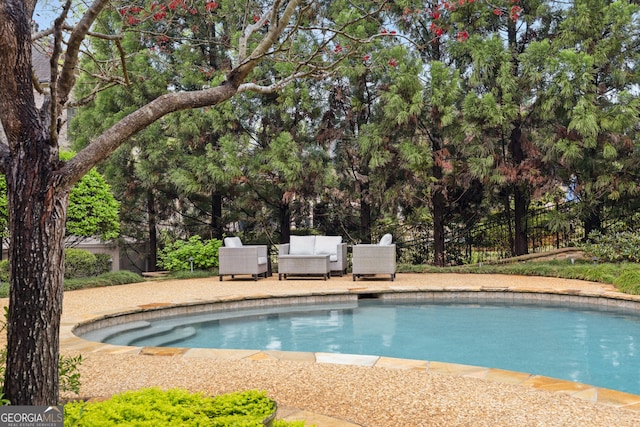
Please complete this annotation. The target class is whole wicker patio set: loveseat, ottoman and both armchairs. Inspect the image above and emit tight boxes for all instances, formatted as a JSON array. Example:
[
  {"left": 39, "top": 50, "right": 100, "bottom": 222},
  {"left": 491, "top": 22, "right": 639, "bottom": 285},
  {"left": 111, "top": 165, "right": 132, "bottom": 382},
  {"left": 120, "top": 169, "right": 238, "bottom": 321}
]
[{"left": 218, "top": 234, "right": 396, "bottom": 281}]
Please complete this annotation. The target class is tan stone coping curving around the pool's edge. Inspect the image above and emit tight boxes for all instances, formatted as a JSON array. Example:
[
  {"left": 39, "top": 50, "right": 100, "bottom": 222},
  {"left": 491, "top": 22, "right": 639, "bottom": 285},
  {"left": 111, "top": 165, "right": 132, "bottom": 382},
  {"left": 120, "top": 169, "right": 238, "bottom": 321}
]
[{"left": 60, "top": 285, "right": 640, "bottom": 412}]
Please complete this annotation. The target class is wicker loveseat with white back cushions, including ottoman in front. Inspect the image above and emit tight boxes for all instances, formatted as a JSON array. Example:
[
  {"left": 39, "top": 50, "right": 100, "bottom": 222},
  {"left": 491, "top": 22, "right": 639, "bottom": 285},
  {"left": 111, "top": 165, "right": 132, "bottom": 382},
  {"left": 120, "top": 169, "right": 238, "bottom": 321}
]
[{"left": 278, "top": 236, "right": 347, "bottom": 280}]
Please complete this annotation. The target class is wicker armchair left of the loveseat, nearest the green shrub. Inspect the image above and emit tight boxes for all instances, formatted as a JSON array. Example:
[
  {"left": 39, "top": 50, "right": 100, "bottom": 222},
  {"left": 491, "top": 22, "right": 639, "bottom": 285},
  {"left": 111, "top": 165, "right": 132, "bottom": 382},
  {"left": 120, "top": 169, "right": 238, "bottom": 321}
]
[{"left": 218, "top": 237, "right": 269, "bottom": 281}]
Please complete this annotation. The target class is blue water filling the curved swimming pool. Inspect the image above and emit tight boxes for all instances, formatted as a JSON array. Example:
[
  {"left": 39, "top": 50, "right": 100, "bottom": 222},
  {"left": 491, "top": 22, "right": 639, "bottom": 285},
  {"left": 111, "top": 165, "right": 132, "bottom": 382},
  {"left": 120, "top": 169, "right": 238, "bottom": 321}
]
[{"left": 91, "top": 300, "right": 640, "bottom": 394}]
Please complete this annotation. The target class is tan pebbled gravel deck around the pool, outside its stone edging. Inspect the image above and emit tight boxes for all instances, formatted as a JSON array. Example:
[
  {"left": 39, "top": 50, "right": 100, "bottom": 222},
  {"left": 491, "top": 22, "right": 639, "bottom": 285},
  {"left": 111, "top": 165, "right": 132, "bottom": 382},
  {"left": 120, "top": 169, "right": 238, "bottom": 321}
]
[{"left": 43, "top": 274, "right": 640, "bottom": 427}]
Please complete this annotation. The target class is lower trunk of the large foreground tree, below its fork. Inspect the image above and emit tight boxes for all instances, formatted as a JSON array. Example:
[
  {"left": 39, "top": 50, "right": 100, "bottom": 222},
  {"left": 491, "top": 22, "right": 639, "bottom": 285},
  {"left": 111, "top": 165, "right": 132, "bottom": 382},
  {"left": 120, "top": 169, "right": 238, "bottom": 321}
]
[{"left": 4, "top": 141, "right": 69, "bottom": 405}]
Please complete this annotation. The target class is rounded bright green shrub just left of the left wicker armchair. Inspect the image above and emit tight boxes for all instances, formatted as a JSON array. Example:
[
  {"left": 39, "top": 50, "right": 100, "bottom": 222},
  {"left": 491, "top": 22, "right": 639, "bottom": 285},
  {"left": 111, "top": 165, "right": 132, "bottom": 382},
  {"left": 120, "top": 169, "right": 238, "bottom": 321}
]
[{"left": 158, "top": 236, "right": 222, "bottom": 271}]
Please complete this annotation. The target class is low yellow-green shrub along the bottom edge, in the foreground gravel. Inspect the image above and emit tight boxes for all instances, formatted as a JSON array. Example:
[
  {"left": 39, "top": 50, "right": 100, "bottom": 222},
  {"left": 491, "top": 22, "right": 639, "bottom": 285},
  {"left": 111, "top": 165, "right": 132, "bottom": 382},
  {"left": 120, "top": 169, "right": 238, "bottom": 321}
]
[{"left": 64, "top": 388, "right": 304, "bottom": 427}]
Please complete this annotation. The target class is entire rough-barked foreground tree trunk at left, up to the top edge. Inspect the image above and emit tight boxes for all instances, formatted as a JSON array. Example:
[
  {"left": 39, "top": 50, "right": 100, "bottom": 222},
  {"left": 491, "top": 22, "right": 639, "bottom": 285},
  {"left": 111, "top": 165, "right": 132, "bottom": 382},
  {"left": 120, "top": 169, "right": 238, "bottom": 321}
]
[{"left": 0, "top": 1, "right": 69, "bottom": 405}]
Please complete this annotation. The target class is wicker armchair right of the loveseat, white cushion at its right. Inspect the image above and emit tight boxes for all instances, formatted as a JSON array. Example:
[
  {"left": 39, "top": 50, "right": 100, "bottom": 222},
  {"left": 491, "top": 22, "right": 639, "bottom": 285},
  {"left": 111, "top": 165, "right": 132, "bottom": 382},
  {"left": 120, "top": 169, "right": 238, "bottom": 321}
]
[{"left": 352, "top": 234, "right": 396, "bottom": 282}]
